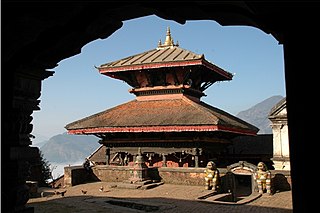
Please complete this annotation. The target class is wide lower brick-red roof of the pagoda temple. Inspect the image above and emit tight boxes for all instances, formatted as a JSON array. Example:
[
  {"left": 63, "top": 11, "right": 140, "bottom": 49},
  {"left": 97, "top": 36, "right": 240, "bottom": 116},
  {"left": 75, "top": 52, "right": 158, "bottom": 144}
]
[{"left": 65, "top": 97, "right": 259, "bottom": 135}]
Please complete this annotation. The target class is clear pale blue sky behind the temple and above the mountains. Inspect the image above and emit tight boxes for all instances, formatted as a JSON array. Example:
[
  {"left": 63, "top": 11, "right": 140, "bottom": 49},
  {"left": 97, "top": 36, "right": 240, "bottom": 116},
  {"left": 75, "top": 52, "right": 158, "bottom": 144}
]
[{"left": 32, "top": 16, "right": 286, "bottom": 143}]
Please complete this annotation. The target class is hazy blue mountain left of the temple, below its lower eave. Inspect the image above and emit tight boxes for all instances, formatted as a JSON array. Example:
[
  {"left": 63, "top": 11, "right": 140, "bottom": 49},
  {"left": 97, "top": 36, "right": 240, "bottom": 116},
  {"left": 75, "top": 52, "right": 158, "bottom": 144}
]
[{"left": 40, "top": 133, "right": 100, "bottom": 163}]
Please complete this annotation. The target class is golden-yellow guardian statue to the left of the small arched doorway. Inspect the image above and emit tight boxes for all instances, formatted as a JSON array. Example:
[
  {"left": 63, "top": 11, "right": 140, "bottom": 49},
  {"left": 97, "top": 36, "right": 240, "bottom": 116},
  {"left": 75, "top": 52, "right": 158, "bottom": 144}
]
[{"left": 204, "top": 161, "right": 220, "bottom": 191}]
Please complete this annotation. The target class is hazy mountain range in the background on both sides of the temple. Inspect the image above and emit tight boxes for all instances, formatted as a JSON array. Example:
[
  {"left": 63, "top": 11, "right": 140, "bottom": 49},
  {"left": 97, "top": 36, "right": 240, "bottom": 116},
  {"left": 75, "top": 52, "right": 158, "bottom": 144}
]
[{"left": 35, "top": 95, "right": 283, "bottom": 163}]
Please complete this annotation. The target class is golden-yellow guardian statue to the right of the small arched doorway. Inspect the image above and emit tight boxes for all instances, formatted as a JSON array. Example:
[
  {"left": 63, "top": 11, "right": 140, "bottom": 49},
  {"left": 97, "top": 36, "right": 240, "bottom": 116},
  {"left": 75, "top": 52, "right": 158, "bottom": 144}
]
[{"left": 254, "top": 162, "right": 271, "bottom": 194}]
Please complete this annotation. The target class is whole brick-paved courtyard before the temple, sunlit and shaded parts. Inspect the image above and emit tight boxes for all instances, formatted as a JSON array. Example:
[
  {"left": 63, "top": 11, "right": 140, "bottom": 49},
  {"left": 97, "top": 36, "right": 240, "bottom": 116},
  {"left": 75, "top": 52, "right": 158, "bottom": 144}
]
[{"left": 27, "top": 182, "right": 292, "bottom": 213}]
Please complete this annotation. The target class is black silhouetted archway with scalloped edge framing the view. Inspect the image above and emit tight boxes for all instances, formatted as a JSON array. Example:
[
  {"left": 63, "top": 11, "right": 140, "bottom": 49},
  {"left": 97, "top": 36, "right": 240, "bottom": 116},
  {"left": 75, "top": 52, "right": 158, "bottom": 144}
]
[{"left": 1, "top": 0, "right": 319, "bottom": 212}]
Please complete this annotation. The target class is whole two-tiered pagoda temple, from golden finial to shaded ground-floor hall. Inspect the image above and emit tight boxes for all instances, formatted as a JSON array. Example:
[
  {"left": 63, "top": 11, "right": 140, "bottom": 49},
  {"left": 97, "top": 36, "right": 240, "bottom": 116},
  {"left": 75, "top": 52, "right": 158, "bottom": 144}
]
[{"left": 65, "top": 28, "right": 259, "bottom": 167}]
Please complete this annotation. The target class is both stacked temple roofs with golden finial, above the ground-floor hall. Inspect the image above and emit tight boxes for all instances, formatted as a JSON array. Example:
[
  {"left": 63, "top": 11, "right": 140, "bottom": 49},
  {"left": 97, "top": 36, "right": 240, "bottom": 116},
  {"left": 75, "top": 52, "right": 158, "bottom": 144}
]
[{"left": 65, "top": 28, "right": 259, "bottom": 135}]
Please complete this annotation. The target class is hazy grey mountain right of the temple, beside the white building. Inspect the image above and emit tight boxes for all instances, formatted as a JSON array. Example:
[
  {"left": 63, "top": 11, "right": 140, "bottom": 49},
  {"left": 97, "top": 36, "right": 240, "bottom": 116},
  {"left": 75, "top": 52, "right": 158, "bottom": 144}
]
[{"left": 236, "top": 95, "right": 283, "bottom": 134}]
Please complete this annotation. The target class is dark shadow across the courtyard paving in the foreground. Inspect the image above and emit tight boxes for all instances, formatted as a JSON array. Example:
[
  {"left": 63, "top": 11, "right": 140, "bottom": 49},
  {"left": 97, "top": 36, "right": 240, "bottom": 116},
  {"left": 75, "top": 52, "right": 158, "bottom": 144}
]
[{"left": 27, "top": 195, "right": 292, "bottom": 213}]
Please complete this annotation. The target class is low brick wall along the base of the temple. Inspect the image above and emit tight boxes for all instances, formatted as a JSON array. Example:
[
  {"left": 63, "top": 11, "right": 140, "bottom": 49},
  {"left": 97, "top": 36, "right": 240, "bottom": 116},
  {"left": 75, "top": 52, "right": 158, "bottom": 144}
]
[{"left": 64, "top": 165, "right": 291, "bottom": 191}]
